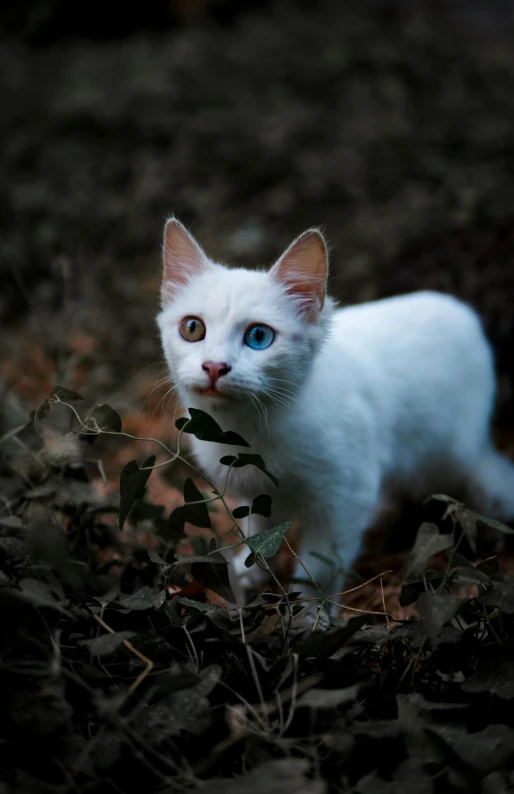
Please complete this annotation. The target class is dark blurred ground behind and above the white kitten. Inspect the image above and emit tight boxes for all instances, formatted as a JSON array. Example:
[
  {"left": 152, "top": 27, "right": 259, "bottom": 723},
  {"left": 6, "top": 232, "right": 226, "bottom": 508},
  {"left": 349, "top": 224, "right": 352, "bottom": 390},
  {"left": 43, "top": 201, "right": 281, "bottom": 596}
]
[{"left": 0, "top": 0, "right": 514, "bottom": 430}]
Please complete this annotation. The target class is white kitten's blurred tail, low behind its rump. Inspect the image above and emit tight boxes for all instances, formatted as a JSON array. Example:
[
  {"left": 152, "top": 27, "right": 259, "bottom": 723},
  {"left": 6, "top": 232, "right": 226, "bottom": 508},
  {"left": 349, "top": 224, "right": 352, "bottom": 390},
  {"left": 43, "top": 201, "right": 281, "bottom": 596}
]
[{"left": 468, "top": 444, "right": 514, "bottom": 522}]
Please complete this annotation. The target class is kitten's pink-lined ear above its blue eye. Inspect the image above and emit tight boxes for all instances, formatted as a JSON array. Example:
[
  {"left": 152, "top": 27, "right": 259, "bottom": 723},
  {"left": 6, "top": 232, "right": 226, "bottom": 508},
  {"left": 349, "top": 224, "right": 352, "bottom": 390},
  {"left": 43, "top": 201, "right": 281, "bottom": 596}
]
[{"left": 270, "top": 229, "right": 328, "bottom": 320}]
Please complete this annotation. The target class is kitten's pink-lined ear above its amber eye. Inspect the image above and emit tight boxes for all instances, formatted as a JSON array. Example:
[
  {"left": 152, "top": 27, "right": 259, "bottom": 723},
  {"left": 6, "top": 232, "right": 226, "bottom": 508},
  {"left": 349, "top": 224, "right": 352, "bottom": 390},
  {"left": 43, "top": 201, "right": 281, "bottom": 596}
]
[{"left": 161, "top": 218, "right": 209, "bottom": 306}]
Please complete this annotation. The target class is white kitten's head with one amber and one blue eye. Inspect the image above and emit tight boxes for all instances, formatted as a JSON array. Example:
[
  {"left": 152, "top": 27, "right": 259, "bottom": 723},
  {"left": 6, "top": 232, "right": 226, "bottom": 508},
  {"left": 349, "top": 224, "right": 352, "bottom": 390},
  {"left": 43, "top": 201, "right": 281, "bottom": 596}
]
[{"left": 157, "top": 218, "right": 332, "bottom": 411}]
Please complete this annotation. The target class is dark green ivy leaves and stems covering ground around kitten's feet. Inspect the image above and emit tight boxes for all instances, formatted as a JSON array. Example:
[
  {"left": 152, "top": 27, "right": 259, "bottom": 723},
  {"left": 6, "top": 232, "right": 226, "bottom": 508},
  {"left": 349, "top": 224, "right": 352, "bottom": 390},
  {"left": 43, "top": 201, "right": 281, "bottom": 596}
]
[{"left": 0, "top": 387, "right": 514, "bottom": 794}]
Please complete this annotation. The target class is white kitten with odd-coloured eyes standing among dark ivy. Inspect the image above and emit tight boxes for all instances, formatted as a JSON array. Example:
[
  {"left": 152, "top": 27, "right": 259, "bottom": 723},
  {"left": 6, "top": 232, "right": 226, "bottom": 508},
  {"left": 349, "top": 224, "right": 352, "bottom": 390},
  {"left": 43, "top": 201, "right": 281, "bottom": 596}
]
[{"left": 158, "top": 218, "right": 514, "bottom": 594}]
